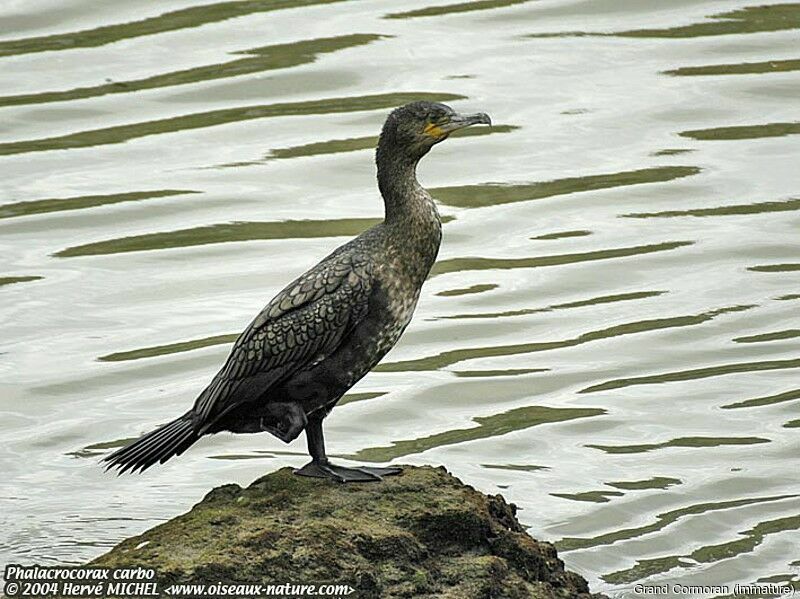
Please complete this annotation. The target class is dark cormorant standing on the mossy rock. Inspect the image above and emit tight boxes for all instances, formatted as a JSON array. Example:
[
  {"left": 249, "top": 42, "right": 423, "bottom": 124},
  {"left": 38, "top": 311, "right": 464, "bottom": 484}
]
[{"left": 103, "top": 101, "right": 491, "bottom": 483}]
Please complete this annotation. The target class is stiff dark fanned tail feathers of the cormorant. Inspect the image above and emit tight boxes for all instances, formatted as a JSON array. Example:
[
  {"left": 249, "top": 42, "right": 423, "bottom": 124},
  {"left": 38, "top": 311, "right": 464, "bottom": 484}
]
[{"left": 103, "top": 412, "right": 200, "bottom": 474}]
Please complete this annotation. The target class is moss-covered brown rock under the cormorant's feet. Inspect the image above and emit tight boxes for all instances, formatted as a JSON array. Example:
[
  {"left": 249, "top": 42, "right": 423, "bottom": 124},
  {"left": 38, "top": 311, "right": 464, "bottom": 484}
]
[{"left": 89, "top": 466, "right": 602, "bottom": 599}]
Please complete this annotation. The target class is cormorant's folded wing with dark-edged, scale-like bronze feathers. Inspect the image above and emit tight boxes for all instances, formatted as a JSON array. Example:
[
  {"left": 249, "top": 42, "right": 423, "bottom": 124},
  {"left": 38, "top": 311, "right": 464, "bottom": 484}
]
[{"left": 194, "top": 252, "right": 372, "bottom": 430}]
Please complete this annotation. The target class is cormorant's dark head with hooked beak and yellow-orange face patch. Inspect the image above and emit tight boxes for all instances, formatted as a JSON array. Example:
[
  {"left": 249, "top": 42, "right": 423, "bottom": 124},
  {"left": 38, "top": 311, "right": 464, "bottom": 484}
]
[{"left": 379, "top": 101, "right": 492, "bottom": 160}]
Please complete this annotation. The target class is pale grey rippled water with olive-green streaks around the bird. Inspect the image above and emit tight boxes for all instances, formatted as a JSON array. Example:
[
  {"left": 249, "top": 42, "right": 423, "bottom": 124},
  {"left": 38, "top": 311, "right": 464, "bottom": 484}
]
[{"left": 0, "top": 0, "right": 800, "bottom": 593}]
